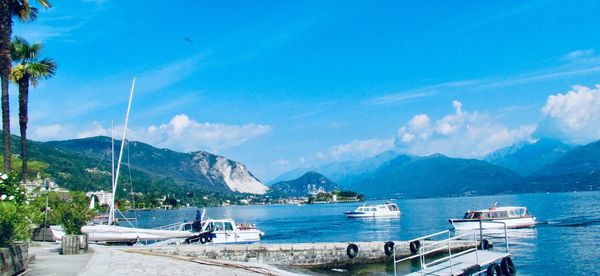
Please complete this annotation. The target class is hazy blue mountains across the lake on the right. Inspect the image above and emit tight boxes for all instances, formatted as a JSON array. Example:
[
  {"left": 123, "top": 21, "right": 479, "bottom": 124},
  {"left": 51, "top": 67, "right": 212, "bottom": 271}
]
[{"left": 277, "top": 139, "right": 600, "bottom": 198}]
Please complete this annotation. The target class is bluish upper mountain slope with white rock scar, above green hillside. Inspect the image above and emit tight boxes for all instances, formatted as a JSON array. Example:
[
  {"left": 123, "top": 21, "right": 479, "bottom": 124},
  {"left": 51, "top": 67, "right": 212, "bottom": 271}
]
[{"left": 44, "top": 137, "right": 268, "bottom": 194}]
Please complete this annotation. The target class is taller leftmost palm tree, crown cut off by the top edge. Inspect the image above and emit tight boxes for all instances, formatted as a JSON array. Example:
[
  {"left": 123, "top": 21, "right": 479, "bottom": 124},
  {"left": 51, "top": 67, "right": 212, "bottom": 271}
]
[{"left": 0, "top": 0, "right": 52, "bottom": 172}]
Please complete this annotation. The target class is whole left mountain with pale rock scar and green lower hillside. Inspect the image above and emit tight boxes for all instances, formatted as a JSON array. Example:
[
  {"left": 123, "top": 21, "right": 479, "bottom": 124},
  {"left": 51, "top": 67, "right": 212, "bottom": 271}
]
[{"left": 6, "top": 136, "right": 268, "bottom": 195}]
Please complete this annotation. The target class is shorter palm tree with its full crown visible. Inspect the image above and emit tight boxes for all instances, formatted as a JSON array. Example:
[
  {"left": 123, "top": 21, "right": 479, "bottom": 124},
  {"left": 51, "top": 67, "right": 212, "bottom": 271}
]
[{"left": 10, "top": 36, "right": 56, "bottom": 183}]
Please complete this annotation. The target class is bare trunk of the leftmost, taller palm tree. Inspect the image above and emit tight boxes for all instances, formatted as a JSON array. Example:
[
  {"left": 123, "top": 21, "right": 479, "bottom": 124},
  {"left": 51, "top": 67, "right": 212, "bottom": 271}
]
[{"left": 0, "top": 0, "right": 12, "bottom": 173}]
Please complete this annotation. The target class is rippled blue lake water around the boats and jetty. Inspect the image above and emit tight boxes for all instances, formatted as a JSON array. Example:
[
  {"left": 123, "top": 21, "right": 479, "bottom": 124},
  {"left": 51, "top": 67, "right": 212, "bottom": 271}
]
[{"left": 127, "top": 192, "right": 600, "bottom": 275}]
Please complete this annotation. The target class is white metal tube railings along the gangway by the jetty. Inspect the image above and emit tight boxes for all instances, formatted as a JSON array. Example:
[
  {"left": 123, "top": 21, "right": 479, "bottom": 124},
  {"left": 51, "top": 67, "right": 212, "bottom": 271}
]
[{"left": 392, "top": 221, "right": 509, "bottom": 275}]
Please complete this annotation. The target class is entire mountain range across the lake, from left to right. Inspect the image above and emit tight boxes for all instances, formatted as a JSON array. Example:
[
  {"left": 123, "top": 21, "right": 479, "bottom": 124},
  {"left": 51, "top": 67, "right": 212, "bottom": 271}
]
[{"left": 5, "top": 136, "right": 600, "bottom": 201}]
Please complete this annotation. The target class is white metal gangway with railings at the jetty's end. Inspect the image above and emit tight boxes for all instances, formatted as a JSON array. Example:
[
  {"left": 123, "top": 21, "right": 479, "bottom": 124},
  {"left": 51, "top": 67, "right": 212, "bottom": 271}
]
[{"left": 392, "top": 221, "right": 509, "bottom": 275}]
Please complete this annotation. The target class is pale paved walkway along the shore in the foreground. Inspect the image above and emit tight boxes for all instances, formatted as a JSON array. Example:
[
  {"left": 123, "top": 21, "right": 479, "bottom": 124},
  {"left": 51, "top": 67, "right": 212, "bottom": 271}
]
[{"left": 28, "top": 243, "right": 302, "bottom": 276}]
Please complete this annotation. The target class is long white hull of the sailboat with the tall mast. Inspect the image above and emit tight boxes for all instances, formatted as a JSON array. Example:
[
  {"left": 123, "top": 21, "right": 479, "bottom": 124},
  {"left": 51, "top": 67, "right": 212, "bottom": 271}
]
[{"left": 50, "top": 225, "right": 198, "bottom": 242}]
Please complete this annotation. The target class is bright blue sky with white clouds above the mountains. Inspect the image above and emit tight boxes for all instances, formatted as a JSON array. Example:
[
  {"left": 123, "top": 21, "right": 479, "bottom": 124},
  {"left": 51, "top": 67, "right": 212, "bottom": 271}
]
[{"left": 11, "top": 0, "right": 600, "bottom": 181}]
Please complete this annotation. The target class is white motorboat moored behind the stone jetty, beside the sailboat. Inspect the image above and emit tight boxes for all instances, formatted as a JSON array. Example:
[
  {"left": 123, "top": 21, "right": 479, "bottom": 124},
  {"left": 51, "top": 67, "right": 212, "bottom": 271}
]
[{"left": 201, "top": 219, "right": 265, "bottom": 244}]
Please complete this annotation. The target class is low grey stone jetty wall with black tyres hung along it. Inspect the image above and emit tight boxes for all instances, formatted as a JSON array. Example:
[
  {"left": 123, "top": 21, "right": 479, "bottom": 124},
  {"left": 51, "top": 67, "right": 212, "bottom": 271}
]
[{"left": 140, "top": 241, "right": 474, "bottom": 268}]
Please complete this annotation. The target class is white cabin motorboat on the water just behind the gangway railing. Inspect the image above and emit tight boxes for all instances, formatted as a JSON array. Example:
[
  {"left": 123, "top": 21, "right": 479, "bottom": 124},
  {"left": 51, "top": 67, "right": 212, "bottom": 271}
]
[{"left": 448, "top": 206, "right": 535, "bottom": 231}]
